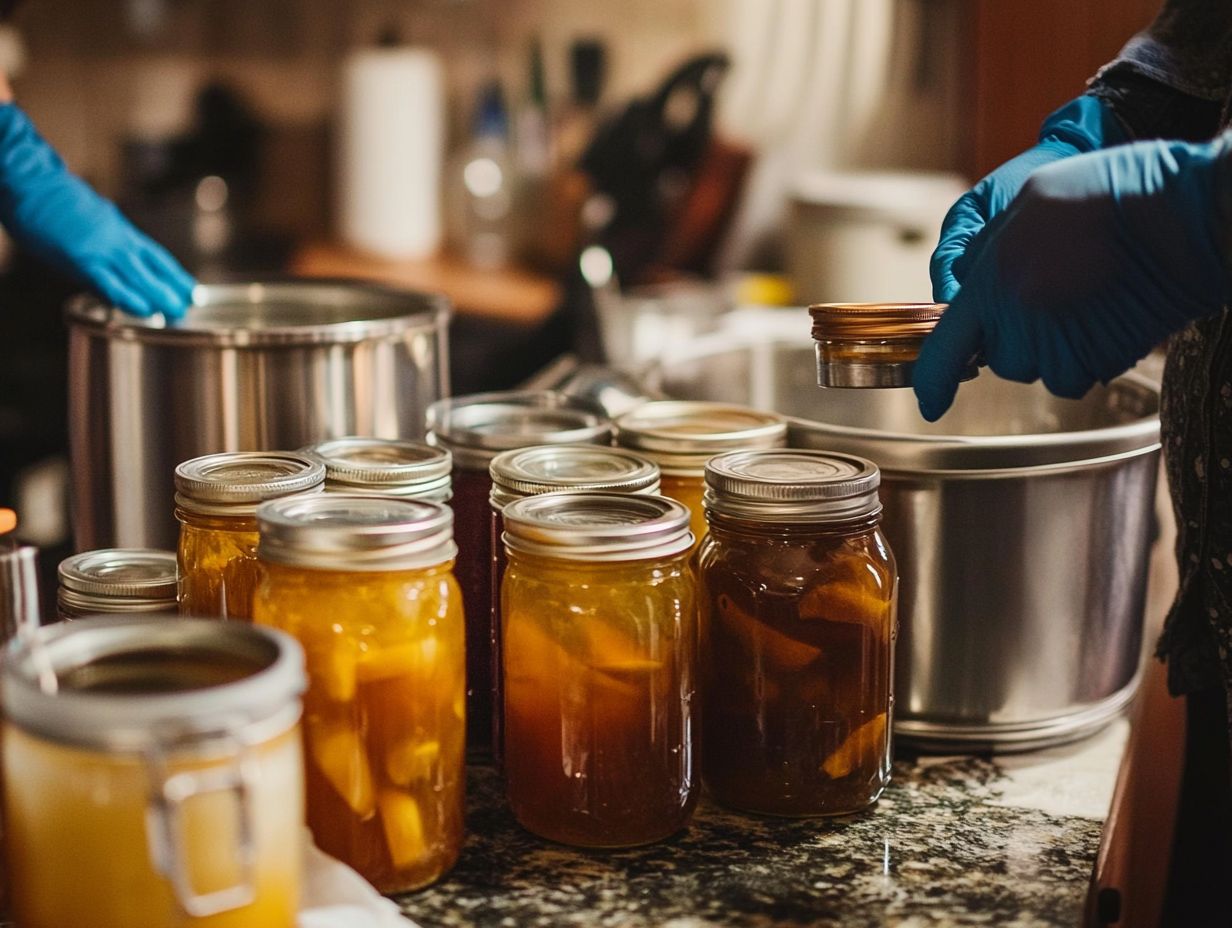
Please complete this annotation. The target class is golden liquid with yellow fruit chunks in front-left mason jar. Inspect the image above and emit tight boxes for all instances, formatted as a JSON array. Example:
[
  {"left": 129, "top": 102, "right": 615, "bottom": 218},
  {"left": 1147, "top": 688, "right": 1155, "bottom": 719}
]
[{"left": 254, "top": 562, "right": 466, "bottom": 892}]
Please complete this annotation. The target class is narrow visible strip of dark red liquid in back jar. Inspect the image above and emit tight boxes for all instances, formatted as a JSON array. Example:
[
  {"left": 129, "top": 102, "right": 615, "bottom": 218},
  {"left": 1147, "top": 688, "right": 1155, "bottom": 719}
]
[{"left": 450, "top": 467, "right": 494, "bottom": 759}]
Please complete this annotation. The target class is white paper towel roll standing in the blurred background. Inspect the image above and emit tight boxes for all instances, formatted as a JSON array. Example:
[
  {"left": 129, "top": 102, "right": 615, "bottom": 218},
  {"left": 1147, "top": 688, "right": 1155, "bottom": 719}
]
[{"left": 339, "top": 48, "right": 445, "bottom": 258}]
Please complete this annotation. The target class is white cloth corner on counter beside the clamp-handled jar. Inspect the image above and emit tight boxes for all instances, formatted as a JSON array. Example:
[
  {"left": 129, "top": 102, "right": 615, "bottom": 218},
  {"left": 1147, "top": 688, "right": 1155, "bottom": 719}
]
[{"left": 297, "top": 834, "right": 415, "bottom": 928}]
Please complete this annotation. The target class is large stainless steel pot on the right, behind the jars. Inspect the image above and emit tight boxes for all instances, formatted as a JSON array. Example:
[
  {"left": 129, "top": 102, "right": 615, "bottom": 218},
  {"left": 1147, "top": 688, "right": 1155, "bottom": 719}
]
[{"left": 650, "top": 339, "right": 1159, "bottom": 751}]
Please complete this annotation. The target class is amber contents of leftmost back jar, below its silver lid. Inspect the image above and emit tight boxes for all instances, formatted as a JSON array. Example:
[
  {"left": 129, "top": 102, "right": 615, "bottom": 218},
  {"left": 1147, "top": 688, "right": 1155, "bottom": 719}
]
[{"left": 175, "top": 508, "right": 260, "bottom": 619}]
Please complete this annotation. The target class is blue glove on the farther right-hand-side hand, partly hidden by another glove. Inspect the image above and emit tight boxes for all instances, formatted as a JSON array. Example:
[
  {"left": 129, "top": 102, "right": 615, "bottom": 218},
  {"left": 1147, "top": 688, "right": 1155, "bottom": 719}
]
[{"left": 929, "top": 95, "right": 1129, "bottom": 303}]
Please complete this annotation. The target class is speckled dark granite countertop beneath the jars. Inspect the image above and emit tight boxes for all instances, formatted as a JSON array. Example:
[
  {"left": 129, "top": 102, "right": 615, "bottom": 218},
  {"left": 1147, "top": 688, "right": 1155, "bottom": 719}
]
[{"left": 399, "top": 720, "right": 1129, "bottom": 928}]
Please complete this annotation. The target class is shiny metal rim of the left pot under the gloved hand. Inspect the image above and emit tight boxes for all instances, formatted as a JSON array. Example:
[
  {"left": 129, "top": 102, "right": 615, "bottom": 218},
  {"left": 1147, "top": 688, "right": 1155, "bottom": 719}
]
[{"left": 64, "top": 276, "right": 451, "bottom": 348}]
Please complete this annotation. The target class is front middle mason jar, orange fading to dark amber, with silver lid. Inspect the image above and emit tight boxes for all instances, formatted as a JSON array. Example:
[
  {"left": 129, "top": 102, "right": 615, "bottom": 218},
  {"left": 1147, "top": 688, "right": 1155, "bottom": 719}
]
[{"left": 501, "top": 492, "right": 699, "bottom": 848}]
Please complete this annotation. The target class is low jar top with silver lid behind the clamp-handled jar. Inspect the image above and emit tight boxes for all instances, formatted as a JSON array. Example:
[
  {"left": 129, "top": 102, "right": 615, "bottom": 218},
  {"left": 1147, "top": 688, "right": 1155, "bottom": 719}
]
[{"left": 55, "top": 548, "right": 177, "bottom": 619}]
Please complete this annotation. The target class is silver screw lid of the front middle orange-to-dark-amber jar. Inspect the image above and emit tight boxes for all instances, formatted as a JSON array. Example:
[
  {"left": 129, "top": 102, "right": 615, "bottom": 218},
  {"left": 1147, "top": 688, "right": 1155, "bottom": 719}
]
[{"left": 501, "top": 490, "right": 694, "bottom": 562}]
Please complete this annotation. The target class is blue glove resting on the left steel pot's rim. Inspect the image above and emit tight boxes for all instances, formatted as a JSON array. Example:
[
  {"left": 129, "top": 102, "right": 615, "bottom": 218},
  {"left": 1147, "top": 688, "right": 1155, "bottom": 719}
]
[{"left": 0, "top": 104, "right": 195, "bottom": 318}]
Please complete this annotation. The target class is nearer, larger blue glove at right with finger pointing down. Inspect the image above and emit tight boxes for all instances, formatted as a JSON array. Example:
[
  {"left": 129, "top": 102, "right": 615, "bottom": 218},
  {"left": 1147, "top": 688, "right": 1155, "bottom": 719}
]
[{"left": 913, "top": 134, "right": 1232, "bottom": 421}]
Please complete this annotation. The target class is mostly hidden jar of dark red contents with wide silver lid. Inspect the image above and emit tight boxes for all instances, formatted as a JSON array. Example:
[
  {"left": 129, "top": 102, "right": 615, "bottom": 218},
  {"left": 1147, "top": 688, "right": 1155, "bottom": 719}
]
[{"left": 428, "top": 392, "right": 612, "bottom": 760}]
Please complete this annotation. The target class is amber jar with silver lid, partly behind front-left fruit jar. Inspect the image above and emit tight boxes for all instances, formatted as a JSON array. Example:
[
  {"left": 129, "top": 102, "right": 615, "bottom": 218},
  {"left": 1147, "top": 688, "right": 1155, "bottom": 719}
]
[{"left": 175, "top": 451, "right": 325, "bottom": 619}]
